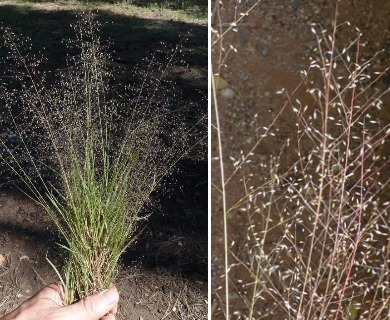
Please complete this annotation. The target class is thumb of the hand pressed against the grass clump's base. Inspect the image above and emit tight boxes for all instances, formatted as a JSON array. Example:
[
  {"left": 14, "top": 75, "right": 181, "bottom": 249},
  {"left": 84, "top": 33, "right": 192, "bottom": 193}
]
[{"left": 63, "top": 288, "right": 119, "bottom": 320}]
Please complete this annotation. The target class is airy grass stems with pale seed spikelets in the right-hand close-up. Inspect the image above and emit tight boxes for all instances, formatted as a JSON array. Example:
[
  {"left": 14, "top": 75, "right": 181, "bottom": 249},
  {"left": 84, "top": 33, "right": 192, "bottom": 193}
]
[{"left": 214, "top": 1, "right": 390, "bottom": 320}]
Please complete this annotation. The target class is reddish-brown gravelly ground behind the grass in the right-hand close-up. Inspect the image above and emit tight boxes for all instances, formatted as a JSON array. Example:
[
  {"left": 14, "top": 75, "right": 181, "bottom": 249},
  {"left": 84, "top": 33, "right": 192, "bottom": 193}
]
[{"left": 211, "top": 0, "right": 390, "bottom": 320}]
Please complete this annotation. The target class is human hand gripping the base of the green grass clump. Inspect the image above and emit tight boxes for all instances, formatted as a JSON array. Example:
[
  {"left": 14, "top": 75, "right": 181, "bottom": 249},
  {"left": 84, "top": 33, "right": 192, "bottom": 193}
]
[{"left": 0, "top": 283, "right": 119, "bottom": 320}]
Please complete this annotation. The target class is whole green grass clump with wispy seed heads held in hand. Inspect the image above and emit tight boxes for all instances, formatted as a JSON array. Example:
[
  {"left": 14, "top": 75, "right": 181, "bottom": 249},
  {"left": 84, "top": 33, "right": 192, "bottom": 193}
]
[{"left": 1, "top": 14, "right": 202, "bottom": 304}]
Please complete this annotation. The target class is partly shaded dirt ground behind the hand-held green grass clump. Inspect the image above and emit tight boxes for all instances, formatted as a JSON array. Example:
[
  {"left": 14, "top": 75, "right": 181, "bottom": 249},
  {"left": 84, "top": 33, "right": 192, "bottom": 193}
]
[{"left": 0, "top": 1, "right": 208, "bottom": 320}]
